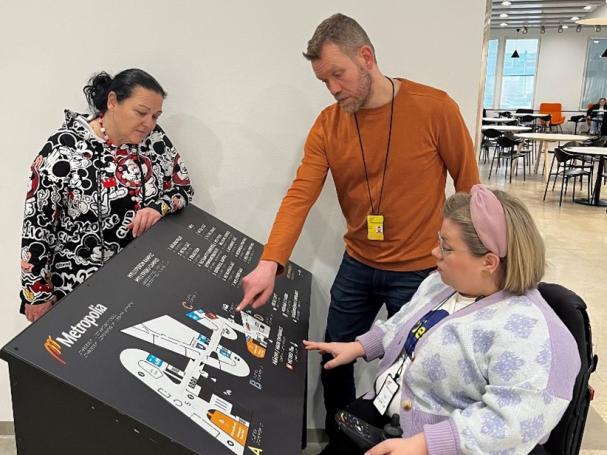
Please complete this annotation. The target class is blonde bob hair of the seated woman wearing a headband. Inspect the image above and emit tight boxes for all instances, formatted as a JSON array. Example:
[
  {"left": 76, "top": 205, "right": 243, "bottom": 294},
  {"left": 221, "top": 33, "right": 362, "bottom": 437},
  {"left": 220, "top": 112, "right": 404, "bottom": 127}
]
[{"left": 443, "top": 190, "right": 546, "bottom": 295}]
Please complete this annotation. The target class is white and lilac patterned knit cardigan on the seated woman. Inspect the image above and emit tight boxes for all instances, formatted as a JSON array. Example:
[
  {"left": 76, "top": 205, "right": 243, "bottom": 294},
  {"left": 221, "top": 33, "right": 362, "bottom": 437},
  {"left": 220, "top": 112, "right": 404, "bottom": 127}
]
[{"left": 357, "top": 273, "right": 580, "bottom": 455}]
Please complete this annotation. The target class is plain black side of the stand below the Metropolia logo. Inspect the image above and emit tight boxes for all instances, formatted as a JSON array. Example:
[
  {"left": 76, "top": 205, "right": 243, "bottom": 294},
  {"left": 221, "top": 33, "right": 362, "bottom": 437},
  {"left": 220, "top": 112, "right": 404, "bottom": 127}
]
[{"left": 9, "top": 362, "right": 194, "bottom": 455}]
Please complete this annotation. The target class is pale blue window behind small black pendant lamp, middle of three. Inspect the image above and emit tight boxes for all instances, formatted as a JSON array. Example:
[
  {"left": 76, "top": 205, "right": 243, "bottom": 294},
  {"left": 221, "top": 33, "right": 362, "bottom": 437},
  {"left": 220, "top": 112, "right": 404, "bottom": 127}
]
[{"left": 500, "top": 39, "right": 538, "bottom": 109}]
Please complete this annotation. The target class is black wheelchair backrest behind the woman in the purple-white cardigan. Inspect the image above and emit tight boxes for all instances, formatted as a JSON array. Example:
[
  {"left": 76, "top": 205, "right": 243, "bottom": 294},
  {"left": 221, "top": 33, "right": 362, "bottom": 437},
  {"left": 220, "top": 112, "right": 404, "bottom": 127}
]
[{"left": 531, "top": 283, "right": 598, "bottom": 455}]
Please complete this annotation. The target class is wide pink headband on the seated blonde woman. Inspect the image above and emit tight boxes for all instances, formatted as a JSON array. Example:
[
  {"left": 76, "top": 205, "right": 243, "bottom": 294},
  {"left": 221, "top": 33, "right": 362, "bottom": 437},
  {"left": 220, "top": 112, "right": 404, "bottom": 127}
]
[{"left": 470, "top": 184, "right": 508, "bottom": 258}]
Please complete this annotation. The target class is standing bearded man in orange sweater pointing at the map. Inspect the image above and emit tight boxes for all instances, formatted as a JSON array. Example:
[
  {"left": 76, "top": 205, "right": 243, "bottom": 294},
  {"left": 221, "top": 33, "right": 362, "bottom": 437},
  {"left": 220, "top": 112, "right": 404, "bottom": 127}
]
[{"left": 238, "top": 14, "right": 479, "bottom": 438}]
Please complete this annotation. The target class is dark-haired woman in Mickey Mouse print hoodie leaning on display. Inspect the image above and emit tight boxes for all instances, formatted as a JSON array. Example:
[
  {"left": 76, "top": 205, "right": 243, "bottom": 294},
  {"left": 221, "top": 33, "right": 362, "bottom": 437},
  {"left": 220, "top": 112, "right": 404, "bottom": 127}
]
[{"left": 20, "top": 69, "right": 193, "bottom": 322}]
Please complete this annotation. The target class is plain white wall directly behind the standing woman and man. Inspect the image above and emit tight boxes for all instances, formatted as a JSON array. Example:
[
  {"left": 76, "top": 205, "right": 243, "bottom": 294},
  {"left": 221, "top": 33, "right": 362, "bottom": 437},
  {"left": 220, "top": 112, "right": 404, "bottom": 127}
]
[{"left": 0, "top": 0, "right": 485, "bottom": 427}]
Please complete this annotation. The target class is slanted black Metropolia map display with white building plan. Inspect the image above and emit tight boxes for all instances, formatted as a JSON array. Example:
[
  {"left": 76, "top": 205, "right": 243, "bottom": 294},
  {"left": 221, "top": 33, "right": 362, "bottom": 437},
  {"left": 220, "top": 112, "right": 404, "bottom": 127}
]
[{"left": 2, "top": 206, "right": 311, "bottom": 455}]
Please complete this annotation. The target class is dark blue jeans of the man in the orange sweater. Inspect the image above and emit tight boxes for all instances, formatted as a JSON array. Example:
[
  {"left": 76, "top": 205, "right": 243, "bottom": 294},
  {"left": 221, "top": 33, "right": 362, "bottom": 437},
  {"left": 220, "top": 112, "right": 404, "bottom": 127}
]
[{"left": 320, "top": 253, "right": 433, "bottom": 436}]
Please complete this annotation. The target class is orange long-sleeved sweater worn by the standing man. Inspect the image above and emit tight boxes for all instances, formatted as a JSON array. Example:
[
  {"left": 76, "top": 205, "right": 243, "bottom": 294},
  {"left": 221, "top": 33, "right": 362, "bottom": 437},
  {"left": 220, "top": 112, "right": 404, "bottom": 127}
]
[{"left": 262, "top": 80, "right": 479, "bottom": 271}]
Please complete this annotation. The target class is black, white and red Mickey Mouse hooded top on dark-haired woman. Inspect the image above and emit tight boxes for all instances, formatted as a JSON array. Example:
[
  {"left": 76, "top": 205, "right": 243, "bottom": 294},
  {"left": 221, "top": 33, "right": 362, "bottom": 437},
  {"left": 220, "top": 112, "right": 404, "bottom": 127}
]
[{"left": 20, "top": 110, "right": 193, "bottom": 313}]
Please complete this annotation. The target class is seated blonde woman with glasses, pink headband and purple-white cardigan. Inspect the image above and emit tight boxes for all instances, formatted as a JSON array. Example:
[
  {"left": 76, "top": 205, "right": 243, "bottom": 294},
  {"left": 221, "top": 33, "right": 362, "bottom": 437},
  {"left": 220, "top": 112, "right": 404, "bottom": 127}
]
[{"left": 305, "top": 185, "right": 580, "bottom": 455}]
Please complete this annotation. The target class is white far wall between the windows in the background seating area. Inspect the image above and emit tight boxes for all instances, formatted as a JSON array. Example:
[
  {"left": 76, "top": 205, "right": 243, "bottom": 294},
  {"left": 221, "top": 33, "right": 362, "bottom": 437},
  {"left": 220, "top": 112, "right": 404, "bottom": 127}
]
[{"left": 489, "top": 27, "right": 607, "bottom": 113}]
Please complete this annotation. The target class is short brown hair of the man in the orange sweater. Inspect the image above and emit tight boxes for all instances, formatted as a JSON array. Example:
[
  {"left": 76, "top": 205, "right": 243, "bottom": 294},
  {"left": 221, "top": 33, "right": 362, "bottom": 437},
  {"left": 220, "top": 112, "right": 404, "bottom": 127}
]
[{"left": 303, "top": 13, "right": 375, "bottom": 61}]
